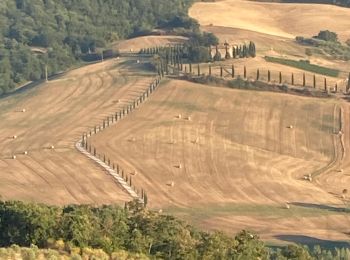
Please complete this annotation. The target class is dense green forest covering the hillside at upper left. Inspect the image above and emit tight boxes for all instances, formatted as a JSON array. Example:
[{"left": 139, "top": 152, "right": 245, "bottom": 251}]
[{"left": 0, "top": 0, "right": 198, "bottom": 94}]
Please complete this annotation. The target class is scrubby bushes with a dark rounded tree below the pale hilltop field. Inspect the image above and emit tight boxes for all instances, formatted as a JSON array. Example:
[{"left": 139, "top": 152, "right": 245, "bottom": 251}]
[{"left": 296, "top": 30, "right": 350, "bottom": 61}]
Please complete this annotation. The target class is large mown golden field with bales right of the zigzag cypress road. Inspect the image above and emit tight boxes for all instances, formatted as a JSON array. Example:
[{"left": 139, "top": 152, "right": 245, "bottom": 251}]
[{"left": 92, "top": 80, "right": 350, "bottom": 244}]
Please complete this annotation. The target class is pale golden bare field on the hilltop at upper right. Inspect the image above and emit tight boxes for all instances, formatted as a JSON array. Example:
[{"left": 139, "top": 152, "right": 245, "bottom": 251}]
[{"left": 190, "top": 0, "right": 350, "bottom": 40}]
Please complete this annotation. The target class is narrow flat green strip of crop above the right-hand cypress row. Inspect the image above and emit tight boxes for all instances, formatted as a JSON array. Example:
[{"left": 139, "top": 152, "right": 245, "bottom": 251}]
[{"left": 265, "top": 56, "right": 339, "bottom": 77}]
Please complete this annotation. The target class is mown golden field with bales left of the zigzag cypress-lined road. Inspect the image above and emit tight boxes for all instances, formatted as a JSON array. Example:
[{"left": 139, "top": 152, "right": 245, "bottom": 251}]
[{"left": 0, "top": 60, "right": 153, "bottom": 204}]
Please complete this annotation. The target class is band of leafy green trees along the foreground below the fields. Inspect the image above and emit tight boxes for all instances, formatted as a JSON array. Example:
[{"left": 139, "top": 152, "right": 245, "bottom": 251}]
[{"left": 0, "top": 201, "right": 350, "bottom": 259}]
